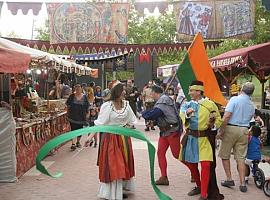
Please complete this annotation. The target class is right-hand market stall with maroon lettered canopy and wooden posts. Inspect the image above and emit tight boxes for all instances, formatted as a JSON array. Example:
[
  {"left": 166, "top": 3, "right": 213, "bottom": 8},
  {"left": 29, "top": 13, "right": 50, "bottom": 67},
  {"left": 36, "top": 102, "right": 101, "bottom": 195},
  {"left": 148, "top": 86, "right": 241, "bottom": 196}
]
[{"left": 210, "top": 42, "right": 270, "bottom": 144}]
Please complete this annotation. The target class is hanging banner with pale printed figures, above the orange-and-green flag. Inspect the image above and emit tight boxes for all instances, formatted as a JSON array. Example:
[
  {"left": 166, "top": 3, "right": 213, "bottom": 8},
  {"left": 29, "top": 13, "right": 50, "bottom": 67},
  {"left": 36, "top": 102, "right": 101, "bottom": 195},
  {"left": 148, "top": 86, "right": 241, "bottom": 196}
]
[{"left": 174, "top": 0, "right": 255, "bottom": 41}]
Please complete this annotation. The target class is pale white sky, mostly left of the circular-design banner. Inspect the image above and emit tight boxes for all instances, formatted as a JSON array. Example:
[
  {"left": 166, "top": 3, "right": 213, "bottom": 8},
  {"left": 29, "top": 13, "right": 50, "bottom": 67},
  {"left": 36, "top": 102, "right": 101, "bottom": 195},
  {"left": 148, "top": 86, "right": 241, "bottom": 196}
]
[{"left": 0, "top": 0, "right": 158, "bottom": 39}]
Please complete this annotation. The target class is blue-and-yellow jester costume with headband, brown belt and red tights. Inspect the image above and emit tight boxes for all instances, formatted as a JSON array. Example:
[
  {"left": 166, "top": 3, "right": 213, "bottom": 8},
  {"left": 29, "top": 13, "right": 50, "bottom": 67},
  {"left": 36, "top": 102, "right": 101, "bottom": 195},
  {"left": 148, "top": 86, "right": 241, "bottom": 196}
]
[{"left": 180, "top": 81, "right": 224, "bottom": 200}]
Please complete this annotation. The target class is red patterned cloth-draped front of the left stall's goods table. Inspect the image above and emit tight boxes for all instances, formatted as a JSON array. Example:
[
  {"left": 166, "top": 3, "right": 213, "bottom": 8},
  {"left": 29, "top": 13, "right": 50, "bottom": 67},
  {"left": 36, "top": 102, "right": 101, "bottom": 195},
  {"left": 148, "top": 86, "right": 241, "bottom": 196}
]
[{"left": 16, "top": 112, "right": 70, "bottom": 178}]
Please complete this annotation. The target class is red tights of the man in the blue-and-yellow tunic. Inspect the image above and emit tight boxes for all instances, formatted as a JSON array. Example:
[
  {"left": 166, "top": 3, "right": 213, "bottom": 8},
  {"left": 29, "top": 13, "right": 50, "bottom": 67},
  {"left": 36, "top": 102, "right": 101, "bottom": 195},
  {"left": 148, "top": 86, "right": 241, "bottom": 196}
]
[{"left": 183, "top": 161, "right": 211, "bottom": 198}]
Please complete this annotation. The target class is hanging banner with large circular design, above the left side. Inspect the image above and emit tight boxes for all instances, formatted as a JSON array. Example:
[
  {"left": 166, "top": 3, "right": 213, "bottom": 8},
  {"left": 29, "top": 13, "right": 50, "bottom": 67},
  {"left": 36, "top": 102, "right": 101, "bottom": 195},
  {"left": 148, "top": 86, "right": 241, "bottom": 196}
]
[{"left": 46, "top": 3, "right": 129, "bottom": 44}]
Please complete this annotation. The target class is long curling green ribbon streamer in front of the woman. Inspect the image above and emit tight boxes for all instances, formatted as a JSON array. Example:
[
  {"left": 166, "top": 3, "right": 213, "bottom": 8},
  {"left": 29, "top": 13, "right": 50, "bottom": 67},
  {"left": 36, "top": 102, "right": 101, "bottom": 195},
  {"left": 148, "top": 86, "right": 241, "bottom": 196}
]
[{"left": 36, "top": 126, "right": 172, "bottom": 200}]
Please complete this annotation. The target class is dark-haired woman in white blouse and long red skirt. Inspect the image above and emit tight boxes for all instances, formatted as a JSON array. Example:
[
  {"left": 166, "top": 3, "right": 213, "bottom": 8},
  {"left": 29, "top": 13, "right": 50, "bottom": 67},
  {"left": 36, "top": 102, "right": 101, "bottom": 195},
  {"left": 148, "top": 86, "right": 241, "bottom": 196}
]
[{"left": 95, "top": 82, "right": 136, "bottom": 200}]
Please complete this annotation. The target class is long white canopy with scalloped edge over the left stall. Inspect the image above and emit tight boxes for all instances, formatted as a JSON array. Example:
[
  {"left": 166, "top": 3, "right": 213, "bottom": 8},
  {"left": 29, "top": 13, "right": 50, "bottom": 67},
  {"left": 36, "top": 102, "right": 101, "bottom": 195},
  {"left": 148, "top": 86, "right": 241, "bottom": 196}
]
[{"left": 0, "top": 37, "right": 92, "bottom": 74}]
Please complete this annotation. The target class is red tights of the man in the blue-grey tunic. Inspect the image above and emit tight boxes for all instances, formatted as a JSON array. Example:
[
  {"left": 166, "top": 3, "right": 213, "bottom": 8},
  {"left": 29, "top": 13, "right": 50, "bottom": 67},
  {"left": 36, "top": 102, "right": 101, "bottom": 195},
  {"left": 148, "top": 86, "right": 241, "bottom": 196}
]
[{"left": 157, "top": 132, "right": 180, "bottom": 176}]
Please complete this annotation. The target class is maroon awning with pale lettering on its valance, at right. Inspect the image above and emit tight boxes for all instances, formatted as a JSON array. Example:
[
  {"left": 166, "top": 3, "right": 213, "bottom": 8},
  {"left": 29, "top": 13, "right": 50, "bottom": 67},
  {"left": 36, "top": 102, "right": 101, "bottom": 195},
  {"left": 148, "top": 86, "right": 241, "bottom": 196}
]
[{"left": 210, "top": 42, "right": 270, "bottom": 71}]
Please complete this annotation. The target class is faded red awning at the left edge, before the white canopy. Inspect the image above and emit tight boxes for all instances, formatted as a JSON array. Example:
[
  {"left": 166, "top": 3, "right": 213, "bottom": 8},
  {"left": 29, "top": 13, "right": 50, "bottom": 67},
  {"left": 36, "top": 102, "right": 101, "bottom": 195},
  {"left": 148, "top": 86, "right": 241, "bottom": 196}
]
[{"left": 0, "top": 47, "right": 31, "bottom": 73}]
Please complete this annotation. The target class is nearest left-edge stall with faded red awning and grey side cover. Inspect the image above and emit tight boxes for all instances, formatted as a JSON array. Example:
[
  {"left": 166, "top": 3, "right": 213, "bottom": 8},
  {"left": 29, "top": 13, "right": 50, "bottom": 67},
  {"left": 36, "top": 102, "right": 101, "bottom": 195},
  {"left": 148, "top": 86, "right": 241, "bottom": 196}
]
[{"left": 0, "top": 48, "right": 31, "bottom": 182}]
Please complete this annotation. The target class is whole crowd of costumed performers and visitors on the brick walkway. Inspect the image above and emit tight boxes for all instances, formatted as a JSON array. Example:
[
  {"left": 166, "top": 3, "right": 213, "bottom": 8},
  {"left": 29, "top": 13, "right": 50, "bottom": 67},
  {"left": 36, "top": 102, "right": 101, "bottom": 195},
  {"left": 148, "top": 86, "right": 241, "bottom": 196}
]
[{"left": 62, "top": 80, "right": 268, "bottom": 200}]
